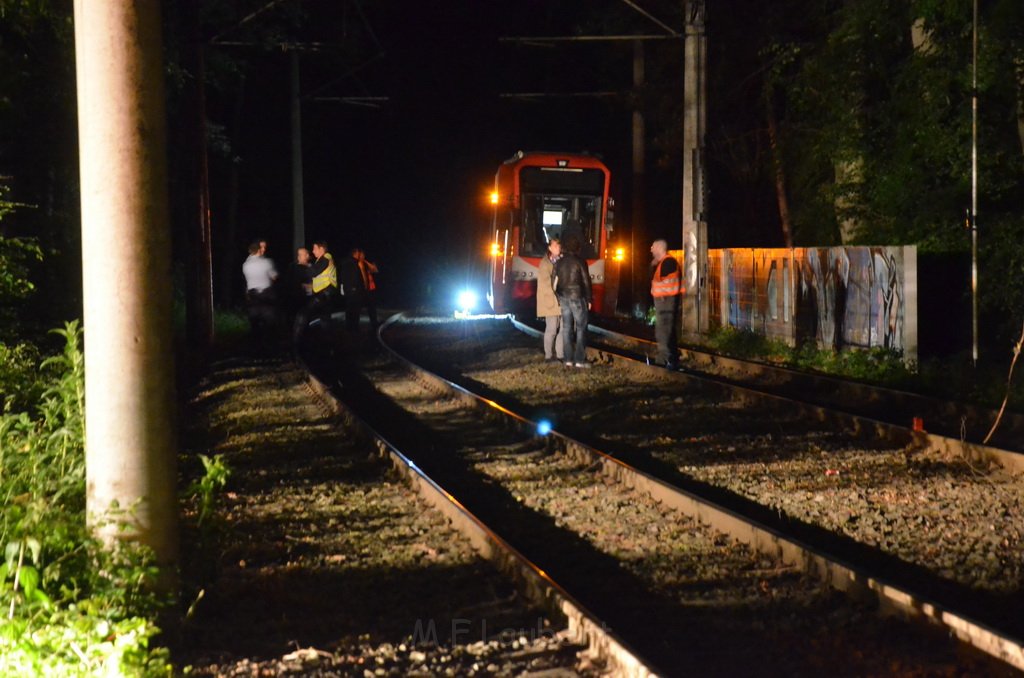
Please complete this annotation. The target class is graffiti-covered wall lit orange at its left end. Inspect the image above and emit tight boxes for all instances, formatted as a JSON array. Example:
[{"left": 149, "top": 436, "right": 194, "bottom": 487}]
[{"left": 708, "top": 247, "right": 918, "bottom": 361}]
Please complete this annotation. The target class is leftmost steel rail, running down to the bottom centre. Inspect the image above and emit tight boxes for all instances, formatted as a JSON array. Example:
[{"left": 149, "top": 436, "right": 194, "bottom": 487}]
[{"left": 294, "top": 342, "right": 664, "bottom": 678}]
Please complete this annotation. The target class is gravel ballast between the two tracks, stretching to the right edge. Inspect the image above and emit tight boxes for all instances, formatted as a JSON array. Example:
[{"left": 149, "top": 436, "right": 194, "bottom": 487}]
[{"left": 382, "top": 319, "right": 1024, "bottom": 596}]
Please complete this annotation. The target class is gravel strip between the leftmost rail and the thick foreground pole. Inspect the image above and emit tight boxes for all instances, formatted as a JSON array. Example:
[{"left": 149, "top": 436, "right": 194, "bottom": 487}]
[{"left": 174, "top": 361, "right": 599, "bottom": 676}]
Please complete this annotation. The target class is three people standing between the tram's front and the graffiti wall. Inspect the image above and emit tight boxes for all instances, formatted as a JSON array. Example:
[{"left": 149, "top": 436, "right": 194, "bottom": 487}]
[{"left": 537, "top": 236, "right": 683, "bottom": 370}]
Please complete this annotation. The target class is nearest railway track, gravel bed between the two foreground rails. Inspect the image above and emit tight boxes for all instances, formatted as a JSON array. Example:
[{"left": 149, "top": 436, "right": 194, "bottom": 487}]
[{"left": 294, "top": 315, "right": 1022, "bottom": 675}]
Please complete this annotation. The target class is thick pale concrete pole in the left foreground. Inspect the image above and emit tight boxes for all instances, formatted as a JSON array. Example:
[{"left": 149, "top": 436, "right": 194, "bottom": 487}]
[{"left": 75, "top": 0, "right": 177, "bottom": 564}]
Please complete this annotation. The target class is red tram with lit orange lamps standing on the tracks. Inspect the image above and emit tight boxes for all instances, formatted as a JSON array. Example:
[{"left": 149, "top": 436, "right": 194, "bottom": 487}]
[{"left": 487, "top": 151, "right": 624, "bottom": 315}]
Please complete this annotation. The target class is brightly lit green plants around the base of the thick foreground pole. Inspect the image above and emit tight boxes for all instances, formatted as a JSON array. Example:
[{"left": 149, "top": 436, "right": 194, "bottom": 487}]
[{"left": 0, "top": 322, "right": 171, "bottom": 676}]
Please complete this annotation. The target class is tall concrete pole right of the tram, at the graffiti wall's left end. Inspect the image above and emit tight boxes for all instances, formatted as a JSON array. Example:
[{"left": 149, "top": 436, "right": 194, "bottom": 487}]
[{"left": 680, "top": 0, "right": 708, "bottom": 338}]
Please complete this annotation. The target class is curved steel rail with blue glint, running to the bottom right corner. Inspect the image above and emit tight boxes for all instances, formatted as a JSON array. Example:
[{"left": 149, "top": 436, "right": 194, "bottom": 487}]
[{"left": 389, "top": 313, "right": 1024, "bottom": 670}]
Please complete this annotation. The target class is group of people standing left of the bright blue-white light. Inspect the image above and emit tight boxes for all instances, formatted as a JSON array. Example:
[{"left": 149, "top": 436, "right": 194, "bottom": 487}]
[{"left": 242, "top": 240, "right": 378, "bottom": 347}]
